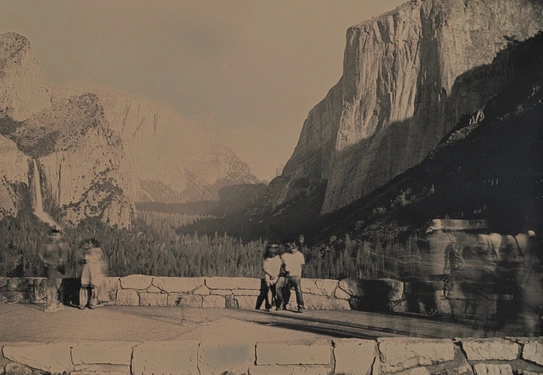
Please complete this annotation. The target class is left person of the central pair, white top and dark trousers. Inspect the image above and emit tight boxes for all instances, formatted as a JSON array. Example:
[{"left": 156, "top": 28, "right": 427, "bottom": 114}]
[{"left": 256, "top": 244, "right": 281, "bottom": 311}]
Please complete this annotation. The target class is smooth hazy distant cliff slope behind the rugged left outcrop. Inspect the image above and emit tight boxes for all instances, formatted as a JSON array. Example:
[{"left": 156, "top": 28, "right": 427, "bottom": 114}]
[{"left": 76, "top": 87, "right": 258, "bottom": 203}]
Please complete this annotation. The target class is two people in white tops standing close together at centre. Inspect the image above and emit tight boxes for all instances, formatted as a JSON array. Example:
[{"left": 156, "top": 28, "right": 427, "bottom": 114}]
[{"left": 256, "top": 235, "right": 305, "bottom": 313}]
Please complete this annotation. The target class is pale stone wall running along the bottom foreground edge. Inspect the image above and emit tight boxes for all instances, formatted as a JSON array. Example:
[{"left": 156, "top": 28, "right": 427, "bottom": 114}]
[{"left": 0, "top": 338, "right": 543, "bottom": 375}]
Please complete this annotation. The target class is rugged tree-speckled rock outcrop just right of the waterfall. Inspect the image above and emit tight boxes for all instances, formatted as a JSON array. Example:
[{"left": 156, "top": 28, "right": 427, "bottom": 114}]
[{"left": 2, "top": 94, "right": 135, "bottom": 227}]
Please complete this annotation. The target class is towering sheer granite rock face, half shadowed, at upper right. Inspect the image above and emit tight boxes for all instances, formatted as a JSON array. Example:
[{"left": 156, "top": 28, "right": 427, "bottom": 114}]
[{"left": 276, "top": 0, "right": 543, "bottom": 213}]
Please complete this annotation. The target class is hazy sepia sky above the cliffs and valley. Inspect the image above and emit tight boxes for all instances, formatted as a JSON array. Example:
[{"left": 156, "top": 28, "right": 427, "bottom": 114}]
[{"left": 0, "top": 0, "right": 406, "bottom": 179}]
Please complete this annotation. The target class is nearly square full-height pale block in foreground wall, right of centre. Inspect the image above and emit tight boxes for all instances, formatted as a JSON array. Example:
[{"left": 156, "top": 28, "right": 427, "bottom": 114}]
[{"left": 333, "top": 339, "right": 379, "bottom": 375}]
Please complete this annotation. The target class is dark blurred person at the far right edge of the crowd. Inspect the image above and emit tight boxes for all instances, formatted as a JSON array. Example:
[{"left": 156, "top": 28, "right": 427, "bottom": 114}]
[{"left": 515, "top": 230, "right": 543, "bottom": 337}]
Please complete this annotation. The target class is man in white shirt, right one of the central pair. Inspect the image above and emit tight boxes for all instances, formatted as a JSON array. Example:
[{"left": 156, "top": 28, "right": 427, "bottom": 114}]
[{"left": 276, "top": 242, "right": 305, "bottom": 313}]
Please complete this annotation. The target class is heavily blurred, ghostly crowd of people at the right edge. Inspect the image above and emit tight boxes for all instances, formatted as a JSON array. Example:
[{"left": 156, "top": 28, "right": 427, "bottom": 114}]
[{"left": 416, "top": 219, "right": 543, "bottom": 336}]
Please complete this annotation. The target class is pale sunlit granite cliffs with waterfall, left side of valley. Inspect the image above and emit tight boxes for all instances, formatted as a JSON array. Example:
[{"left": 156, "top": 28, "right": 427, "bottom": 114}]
[{"left": 0, "top": 33, "right": 257, "bottom": 227}]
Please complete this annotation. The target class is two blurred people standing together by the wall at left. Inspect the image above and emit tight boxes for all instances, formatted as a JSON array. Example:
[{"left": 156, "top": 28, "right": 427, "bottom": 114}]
[{"left": 39, "top": 228, "right": 107, "bottom": 312}]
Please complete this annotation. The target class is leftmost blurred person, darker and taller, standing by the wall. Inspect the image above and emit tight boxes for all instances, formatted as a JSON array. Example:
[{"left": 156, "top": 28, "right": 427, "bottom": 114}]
[{"left": 39, "top": 229, "right": 68, "bottom": 312}]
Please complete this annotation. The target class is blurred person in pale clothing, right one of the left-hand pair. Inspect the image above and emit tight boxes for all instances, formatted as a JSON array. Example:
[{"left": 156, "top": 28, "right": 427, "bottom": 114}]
[{"left": 79, "top": 238, "right": 106, "bottom": 310}]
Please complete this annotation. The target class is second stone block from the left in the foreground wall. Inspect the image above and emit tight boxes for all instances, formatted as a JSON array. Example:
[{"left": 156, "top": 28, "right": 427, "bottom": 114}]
[{"left": 72, "top": 341, "right": 138, "bottom": 370}]
